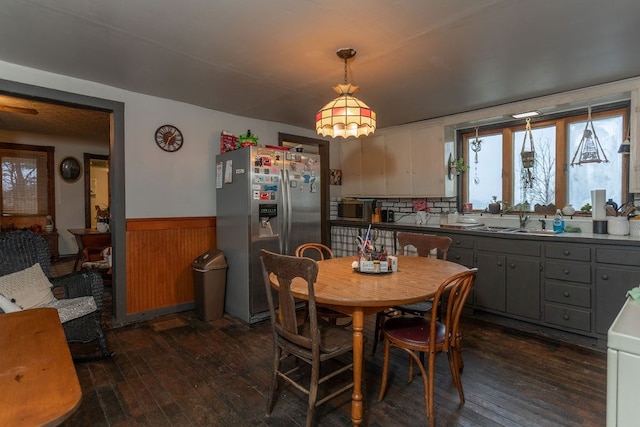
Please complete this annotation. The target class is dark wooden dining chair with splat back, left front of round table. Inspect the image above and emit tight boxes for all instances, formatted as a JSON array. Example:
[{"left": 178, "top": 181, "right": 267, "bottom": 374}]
[{"left": 260, "top": 249, "right": 353, "bottom": 427}]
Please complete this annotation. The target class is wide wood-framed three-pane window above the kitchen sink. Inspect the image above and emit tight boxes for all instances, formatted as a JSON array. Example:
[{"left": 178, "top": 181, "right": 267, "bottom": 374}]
[{"left": 461, "top": 105, "right": 629, "bottom": 211}]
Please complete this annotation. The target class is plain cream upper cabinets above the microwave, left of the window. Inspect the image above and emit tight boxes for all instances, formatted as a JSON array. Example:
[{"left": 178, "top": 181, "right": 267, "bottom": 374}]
[{"left": 341, "top": 125, "right": 455, "bottom": 197}]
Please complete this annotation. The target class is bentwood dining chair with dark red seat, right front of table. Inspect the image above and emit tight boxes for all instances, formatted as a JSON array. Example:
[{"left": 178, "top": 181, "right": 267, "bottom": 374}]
[{"left": 378, "top": 268, "right": 478, "bottom": 426}]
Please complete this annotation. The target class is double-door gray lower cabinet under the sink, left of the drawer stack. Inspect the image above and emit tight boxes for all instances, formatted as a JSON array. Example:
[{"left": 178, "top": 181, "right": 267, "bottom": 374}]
[{"left": 475, "top": 238, "right": 541, "bottom": 320}]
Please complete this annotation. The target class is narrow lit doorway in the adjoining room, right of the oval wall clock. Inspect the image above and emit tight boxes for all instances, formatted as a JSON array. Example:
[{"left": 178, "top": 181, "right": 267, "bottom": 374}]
[{"left": 84, "top": 153, "right": 111, "bottom": 229}]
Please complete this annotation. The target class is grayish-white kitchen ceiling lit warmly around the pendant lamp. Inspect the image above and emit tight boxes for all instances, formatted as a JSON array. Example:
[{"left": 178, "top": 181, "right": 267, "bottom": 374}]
[{"left": 0, "top": 0, "right": 640, "bottom": 137}]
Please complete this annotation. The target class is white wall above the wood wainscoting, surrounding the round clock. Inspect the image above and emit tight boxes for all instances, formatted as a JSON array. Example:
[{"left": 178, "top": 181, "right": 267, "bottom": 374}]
[{"left": 0, "top": 61, "right": 332, "bottom": 224}]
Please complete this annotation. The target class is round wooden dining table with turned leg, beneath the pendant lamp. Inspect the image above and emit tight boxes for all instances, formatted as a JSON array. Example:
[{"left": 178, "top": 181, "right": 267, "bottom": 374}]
[{"left": 292, "top": 256, "right": 467, "bottom": 425}]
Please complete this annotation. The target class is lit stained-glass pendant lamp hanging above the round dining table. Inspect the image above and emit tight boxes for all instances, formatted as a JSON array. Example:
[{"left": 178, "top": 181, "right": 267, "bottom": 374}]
[{"left": 316, "top": 48, "right": 376, "bottom": 138}]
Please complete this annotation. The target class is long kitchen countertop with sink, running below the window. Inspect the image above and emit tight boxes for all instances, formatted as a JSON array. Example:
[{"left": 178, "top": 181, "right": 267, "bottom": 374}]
[{"left": 329, "top": 215, "right": 640, "bottom": 246}]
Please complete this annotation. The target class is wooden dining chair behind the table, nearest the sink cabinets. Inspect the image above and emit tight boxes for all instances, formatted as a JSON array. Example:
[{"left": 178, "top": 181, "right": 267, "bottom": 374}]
[{"left": 371, "top": 232, "right": 451, "bottom": 354}]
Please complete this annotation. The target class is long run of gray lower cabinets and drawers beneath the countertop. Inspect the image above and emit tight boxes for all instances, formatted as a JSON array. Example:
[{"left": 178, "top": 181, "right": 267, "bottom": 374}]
[{"left": 332, "top": 222, "right": 640, "bottom": 348}]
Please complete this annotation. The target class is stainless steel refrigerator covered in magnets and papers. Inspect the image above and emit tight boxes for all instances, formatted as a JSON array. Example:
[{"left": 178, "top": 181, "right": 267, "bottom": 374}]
[{"left": 216, "top": 146, "right": 321, "bottom": 323}]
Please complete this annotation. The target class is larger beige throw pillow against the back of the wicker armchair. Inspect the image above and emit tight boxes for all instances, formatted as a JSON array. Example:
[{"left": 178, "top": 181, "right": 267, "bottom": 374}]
[{"left": 0, "top": 264, "right": 56, "bottom": 310}]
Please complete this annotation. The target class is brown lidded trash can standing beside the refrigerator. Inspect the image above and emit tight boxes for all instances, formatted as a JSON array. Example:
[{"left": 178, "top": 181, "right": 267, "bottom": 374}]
[{"left": 191, "top": 249, "right": 228, "bottom": 322}]
